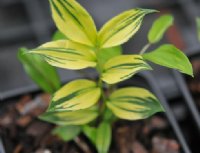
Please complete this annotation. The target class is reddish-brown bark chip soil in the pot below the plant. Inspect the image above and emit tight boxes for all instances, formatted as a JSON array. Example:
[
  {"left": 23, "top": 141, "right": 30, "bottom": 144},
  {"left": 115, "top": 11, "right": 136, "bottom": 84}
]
[{"left": 0, "top": 94, "right": 180, "bottom": 153}]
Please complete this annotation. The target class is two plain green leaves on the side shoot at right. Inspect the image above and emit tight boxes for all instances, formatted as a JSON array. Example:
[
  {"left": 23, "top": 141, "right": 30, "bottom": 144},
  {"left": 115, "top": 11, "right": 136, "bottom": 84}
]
[{"left": 142, "top": 15, "right": 193, "bottom": 76}]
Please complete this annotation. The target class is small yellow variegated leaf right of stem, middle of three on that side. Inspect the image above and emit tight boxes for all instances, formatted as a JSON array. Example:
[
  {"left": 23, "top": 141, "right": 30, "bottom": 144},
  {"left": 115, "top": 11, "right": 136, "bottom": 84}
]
[{"left": 102, "top": 55, "right": 151, "bottom": 84}]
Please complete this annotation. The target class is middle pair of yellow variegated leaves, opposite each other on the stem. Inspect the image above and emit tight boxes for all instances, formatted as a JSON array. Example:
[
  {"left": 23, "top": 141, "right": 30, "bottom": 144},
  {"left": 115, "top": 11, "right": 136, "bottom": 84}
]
[{"left": 31, "top": 40, "right": 151, "bottom": 84}]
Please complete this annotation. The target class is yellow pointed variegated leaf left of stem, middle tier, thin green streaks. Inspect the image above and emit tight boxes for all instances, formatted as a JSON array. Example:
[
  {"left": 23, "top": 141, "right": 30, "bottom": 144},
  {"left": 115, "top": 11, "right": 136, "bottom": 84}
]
[{"left": 30, "top": 40, "right": 96, "bottom": 70}]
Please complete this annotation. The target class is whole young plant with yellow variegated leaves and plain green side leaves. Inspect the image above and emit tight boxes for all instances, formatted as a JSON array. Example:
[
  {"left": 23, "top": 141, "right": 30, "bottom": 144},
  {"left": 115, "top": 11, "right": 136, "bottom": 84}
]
[{"left": 19, "top": 0, "right": 193, "bottom": 153}]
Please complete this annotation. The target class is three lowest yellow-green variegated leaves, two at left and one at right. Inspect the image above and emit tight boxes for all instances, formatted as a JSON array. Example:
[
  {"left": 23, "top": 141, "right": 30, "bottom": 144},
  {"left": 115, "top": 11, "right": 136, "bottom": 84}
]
[{"left": 41, "top": 79, "right": 163, "bottom": 125}]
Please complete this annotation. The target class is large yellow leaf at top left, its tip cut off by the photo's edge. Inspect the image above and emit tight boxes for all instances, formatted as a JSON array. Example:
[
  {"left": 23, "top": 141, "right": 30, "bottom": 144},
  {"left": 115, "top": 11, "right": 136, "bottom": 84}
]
[{"left": 49, "top": 0, "right": 97, "bottom": 46}]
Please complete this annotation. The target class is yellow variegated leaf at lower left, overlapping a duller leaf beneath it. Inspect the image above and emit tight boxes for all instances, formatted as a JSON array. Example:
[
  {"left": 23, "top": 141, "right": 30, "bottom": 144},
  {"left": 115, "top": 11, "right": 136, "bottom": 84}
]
[{"left": 48, "top": 79, "right": 101, "bottom": 111}]
